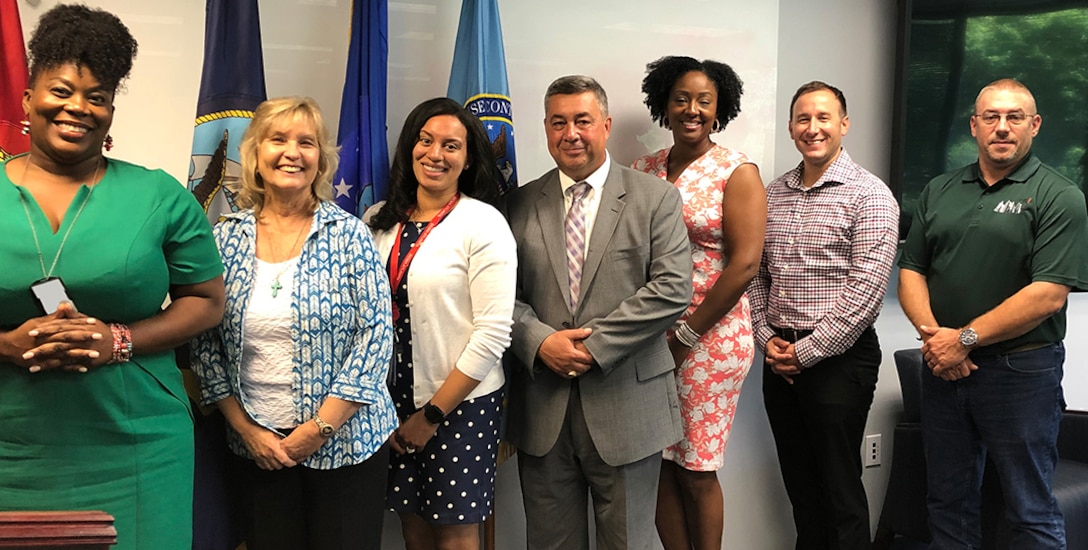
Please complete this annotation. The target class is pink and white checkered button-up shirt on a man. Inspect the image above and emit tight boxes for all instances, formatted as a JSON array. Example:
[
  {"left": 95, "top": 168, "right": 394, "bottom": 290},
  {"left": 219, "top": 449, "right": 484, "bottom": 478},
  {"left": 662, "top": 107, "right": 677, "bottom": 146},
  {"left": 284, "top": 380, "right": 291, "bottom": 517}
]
[{"left": 749, "top": 149, "right": 899, "bottom": 367}]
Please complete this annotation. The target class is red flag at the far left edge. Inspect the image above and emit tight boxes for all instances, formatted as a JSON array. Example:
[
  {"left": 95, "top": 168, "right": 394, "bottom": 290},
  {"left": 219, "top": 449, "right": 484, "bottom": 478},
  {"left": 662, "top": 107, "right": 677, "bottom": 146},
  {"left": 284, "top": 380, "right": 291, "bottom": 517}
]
[{"left": 0, "top": 0, "right": 30, "bottom": 161}]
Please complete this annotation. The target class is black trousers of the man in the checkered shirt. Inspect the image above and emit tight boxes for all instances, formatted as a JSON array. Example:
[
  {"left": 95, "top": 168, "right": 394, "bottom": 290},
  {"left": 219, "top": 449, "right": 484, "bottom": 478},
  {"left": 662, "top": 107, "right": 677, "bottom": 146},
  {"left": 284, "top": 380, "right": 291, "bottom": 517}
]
[{"left": 763, "top": 327, "right": 880, "bottom": 550}]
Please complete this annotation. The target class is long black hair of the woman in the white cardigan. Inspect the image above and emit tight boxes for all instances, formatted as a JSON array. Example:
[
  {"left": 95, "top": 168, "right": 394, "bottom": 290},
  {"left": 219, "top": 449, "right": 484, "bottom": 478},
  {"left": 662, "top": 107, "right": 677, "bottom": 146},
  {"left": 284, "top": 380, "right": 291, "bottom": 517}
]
[{"left": 370, "top": 98, "right": 503, "bottom": 230}]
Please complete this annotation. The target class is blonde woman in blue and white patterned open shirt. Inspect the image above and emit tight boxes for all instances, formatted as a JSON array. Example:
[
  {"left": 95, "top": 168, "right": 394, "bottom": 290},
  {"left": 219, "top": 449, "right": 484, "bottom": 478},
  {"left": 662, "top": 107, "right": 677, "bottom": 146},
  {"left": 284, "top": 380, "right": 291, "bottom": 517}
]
[{"left": 193, "top": 98, "right": 396, "bottom": 550}]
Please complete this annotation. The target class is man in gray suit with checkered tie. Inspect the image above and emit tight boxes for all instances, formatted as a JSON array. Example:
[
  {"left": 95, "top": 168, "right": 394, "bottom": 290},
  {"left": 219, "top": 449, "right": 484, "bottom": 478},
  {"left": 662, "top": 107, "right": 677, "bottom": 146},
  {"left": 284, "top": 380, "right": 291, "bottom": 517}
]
[{"left": 507, "top": 76, "right": 692, "bottom": 550}]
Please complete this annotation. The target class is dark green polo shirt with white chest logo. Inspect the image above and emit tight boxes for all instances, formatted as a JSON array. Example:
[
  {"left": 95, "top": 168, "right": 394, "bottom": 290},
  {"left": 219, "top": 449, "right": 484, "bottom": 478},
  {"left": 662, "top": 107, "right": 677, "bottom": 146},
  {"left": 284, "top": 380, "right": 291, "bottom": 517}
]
[{"left": 899, "top": 153, "right": 1088, "bottom": 353}]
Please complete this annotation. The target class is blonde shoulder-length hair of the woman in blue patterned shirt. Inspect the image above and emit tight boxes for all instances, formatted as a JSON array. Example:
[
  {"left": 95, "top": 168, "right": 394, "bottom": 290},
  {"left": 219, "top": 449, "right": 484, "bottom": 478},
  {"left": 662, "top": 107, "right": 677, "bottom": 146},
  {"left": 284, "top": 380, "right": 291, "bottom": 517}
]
[{"left": 234, "top": 97, "right": 339, "bottom": 213}]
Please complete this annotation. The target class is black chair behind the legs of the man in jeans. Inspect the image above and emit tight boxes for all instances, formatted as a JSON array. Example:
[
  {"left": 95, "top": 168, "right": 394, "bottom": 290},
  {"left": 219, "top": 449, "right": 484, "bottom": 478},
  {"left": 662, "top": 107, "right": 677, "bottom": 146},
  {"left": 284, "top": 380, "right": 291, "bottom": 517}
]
[{"left": 874, "top": 349, "right": 1088, "bottom": 550}]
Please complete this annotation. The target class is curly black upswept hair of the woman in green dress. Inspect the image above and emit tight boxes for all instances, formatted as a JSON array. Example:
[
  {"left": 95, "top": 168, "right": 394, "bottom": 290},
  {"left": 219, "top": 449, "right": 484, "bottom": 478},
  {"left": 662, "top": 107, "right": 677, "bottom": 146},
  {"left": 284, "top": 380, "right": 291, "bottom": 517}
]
[{"left": 27, "top": 4, "right": 136, "bottom": 91}]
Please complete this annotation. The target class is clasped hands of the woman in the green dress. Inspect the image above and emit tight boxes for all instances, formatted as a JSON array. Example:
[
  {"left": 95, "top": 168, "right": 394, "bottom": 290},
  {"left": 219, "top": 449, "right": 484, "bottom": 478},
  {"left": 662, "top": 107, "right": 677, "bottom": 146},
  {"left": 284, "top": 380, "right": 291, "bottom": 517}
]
[{"left": 8, "top": 302, "right": 113, "bottom": 373}]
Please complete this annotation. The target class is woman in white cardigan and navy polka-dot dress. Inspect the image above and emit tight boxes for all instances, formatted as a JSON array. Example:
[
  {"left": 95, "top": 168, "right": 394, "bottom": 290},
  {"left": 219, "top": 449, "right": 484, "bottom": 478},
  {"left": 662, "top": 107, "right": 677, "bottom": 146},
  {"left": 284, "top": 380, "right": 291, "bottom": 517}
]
[{"left": 367, "top": 98, "right": 517, "bottom": 550}]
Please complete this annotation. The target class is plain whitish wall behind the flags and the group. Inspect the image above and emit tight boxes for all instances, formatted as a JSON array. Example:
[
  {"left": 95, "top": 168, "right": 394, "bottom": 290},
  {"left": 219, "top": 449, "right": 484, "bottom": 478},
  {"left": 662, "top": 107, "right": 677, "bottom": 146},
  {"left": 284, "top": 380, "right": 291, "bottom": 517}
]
[{"left": 18, "top": 0, "right": 1088, "bottom": 549}]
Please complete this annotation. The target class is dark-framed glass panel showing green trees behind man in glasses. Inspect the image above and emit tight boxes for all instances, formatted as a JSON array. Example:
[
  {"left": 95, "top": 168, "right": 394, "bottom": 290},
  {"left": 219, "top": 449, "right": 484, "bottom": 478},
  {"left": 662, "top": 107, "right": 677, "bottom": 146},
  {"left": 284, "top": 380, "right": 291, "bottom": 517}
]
[{"left": 892, "top": 0, "right": 1088, "bottom": 228}]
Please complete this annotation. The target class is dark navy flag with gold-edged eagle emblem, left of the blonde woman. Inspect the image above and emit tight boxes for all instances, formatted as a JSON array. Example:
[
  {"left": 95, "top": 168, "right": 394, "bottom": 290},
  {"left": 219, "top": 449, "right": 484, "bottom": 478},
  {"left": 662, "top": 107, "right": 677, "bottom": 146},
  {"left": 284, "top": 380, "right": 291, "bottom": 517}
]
[{"left": 188, "top": 0, "right": 268, "bottom": 224}]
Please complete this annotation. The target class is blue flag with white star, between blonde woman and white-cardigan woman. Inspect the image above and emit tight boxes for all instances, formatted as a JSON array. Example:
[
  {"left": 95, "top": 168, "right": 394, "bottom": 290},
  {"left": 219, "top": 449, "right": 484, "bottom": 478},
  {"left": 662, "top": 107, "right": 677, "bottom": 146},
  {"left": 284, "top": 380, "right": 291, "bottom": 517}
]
[{"left": 333, "top": 0, "right": 390, "bottom": 215}]
